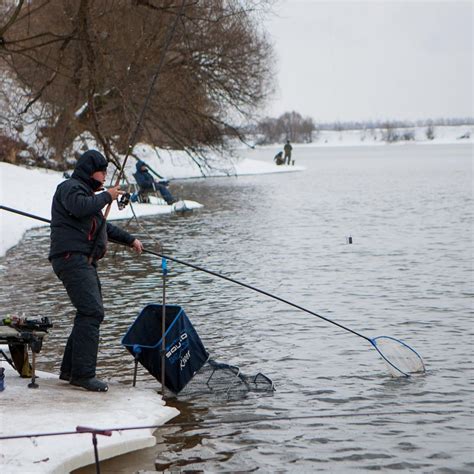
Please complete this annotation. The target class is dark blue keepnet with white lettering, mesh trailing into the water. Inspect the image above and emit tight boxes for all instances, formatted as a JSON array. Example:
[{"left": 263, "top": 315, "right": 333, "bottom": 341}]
[{"left": 122, "top": 304, "right": 274, "bottom": 396}]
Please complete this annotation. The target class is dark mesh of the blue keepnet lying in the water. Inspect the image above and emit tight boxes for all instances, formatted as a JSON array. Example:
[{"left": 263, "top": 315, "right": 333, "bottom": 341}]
[{"left": 179, "top": 359, "right": 275, "bottom": 398}]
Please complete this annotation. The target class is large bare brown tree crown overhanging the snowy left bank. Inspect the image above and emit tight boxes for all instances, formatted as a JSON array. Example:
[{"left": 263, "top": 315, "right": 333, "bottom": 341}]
[{"left": 0, "top": 0, "right": 273, "bottom": 168}]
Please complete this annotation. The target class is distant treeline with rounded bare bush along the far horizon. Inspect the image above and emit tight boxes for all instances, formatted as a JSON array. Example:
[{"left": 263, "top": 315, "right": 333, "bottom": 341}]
[{"left": 248, "top": 111, "right": 474, "bottom": 145}]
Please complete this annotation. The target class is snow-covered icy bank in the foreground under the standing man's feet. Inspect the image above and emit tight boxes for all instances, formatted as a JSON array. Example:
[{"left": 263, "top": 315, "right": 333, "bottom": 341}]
[{"left": 0, "top": 364, "right": 179, "bottom": 474}]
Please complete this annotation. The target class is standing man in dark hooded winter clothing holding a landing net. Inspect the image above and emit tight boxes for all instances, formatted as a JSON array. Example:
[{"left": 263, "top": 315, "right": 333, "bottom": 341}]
[{"left": 49, "top": 150, "right": 143, "bottom": 392}]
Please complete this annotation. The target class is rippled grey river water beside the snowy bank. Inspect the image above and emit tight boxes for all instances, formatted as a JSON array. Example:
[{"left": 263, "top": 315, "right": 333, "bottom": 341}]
[{"left": 0, "top": 145, "right": 474, "bottom": 473}]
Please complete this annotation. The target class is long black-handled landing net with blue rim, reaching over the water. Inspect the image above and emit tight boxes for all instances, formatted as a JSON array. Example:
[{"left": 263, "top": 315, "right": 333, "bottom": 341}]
[{"left": 0, "top": 205, "right": 425, "bottom": 377}]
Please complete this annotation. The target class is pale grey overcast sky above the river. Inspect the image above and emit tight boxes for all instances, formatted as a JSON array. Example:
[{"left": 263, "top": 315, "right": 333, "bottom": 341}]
[{"left": 266, "top": 0, "right": 474, "bottom": 122}]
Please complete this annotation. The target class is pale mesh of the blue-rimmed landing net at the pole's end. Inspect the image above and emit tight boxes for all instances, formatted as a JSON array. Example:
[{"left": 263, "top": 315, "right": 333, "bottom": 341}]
[{"left": 371, "top": 336, "right": 425, "bottom": 377}]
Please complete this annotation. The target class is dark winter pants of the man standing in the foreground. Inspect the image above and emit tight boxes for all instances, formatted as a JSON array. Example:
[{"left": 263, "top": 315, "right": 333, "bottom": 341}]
[{"left": 51, "top": 253, "right": 104, "bottom": 379}]
